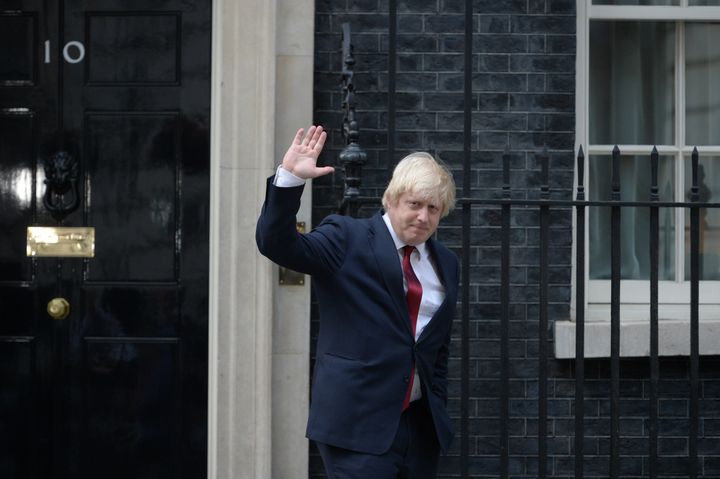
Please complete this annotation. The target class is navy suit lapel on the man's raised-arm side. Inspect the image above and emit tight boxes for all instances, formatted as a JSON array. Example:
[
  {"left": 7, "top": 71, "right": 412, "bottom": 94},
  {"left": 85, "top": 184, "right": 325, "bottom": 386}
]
[{"left": 369, "top": 213, "right": 412, "bottom": 335}]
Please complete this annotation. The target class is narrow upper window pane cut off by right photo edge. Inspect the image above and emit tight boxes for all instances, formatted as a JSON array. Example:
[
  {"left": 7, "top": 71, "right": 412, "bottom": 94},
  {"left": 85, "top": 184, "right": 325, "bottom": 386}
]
[{"left": 685, "top": 23, "right": 720, "bottom": 145}]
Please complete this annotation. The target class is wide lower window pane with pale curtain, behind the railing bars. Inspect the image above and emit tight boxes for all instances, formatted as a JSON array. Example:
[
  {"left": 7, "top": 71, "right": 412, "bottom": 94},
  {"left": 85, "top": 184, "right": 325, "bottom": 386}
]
[{"left": 588, "top": 155, "right": 675, "bottom": 280}]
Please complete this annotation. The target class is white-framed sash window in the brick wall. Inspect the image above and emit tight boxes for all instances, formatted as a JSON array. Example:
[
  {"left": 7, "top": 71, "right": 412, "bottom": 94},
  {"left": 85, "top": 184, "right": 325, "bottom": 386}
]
[{"left": 556, "top": 0, "right": 720, "bottom": 355}]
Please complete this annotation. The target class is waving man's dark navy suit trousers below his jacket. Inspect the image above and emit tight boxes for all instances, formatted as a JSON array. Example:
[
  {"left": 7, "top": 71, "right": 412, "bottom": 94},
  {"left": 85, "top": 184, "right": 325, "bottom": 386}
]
[{"left": 316, "top": 399, "right": 440, "bottom": 479}]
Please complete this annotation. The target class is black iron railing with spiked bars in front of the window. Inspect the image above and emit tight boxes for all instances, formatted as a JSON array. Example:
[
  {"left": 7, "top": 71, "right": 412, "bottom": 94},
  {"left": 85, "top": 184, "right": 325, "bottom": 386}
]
[{"left": 345, "top": 142, "right": 720, "bottom": 478}]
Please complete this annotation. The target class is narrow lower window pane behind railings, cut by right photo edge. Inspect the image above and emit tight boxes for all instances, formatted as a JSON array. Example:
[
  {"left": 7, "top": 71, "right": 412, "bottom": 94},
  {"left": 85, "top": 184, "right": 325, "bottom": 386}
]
[{"left": 685, "top": 156, "right": 720, "bottom": 281}]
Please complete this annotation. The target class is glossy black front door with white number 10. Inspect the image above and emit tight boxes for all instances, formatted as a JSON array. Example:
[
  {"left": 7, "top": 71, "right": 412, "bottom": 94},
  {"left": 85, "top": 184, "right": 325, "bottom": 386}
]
[{"left": 0, "top": 0, "right": 211, "bottom": 479}]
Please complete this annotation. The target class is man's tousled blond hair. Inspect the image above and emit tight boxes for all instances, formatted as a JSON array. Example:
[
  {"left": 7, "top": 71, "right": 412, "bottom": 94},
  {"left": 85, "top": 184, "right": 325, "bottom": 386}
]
[{"left": 383, "top": 151, "right": 455, "bottom": 217}]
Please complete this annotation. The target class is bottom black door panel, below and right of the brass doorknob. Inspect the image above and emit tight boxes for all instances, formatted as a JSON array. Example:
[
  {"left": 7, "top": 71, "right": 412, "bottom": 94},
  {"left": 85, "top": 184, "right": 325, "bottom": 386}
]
[{"left": 84, "top": 338, "right": 180, "bottom": 479}]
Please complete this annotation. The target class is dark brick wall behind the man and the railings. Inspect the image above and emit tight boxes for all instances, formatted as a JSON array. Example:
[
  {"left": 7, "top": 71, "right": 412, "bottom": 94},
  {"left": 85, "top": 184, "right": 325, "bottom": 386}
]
[{"left": 310, "top": 0, "right": 720, "bottom": 478}]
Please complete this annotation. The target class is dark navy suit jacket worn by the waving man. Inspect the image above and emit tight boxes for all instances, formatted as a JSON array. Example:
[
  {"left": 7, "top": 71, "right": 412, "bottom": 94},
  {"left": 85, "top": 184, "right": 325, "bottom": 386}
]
[{"left": 256, "top": 178, "right": 458, "bottom": 454}]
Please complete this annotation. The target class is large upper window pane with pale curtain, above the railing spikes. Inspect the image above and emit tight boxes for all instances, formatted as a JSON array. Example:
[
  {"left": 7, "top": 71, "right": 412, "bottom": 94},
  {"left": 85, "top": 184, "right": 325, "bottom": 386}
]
[{"left": 589, "top": 21, "right": 675, "bottom": 145}]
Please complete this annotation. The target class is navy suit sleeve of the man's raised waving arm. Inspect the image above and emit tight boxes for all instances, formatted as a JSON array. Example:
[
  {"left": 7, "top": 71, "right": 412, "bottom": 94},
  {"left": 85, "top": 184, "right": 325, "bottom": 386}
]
[{"left": 255, "top": 177, "right": 345, "bottom": 275}]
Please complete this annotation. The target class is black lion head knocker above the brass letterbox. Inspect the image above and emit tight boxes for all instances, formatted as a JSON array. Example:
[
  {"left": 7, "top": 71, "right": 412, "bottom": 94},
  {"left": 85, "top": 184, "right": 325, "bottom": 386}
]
[{"left": 43, "top": 151, "right": 80, "bottom": 221}]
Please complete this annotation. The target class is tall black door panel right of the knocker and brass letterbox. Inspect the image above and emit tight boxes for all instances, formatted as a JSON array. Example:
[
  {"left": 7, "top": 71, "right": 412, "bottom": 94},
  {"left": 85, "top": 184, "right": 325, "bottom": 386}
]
[{"left": 85, "top": 111, "right": 182, "bottom": 282}]
